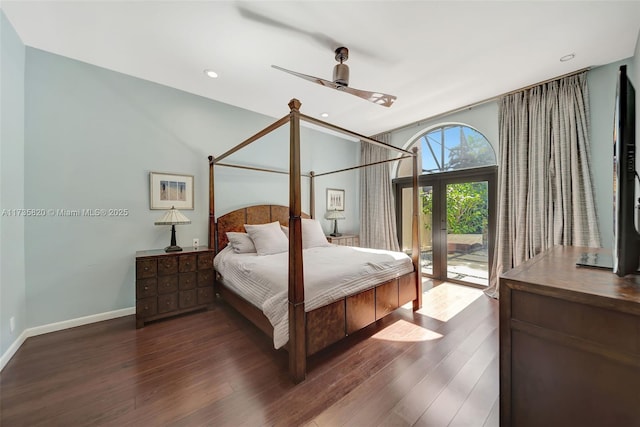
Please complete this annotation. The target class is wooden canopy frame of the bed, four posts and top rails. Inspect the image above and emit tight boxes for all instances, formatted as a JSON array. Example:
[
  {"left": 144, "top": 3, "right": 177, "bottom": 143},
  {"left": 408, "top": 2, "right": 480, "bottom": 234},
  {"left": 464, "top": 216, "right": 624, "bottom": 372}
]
[{"left": 208, "top": 99, "right": 422, "bottom": 383}]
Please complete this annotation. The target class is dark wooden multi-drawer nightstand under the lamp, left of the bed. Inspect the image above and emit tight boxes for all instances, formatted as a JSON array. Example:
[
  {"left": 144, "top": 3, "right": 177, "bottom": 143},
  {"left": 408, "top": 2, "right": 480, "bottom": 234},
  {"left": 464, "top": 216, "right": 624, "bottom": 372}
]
[{"left": 136, "top": 248, "right": 214, "bottom": 328}]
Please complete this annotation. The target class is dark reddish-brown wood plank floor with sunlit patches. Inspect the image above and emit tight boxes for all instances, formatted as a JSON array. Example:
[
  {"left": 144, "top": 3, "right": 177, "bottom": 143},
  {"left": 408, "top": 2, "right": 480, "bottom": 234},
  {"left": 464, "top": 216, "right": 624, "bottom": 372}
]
[{"left": 0, "top": 283, "right": 498, "bottom": 427}]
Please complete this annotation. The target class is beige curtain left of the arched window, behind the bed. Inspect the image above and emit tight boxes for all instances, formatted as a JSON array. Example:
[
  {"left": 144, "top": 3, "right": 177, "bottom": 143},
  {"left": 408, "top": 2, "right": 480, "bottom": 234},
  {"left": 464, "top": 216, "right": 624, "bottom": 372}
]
[{"left": 360, "top": 134, "right": 400, "bottom": 251}]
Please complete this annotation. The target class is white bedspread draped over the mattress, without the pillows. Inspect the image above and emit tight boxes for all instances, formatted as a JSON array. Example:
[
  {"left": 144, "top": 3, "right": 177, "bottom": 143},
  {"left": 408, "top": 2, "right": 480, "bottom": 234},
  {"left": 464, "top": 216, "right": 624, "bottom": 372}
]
[{"left": 213, "top": 245, "right": 413, "bottom": 348}]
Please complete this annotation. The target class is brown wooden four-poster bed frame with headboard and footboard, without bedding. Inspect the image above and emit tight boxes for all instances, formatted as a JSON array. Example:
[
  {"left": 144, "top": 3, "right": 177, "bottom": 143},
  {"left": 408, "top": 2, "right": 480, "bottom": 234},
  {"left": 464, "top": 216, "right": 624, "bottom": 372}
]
[{"left": 209, "top": 99, "right": 422, "bottom": 382}]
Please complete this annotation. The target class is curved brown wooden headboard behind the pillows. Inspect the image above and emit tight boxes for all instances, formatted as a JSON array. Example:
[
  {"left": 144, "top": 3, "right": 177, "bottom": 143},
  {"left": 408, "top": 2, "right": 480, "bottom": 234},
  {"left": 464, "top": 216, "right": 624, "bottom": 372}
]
[{"left": 215, "top": 205, "right": 309, "bottom": 253}]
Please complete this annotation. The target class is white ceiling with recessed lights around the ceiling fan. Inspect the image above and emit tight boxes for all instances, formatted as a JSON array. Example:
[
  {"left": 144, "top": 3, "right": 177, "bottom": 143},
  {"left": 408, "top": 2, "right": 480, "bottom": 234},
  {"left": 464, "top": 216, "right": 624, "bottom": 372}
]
[{"left": 2, "top": 0, "right": 640, "bottom": 135}]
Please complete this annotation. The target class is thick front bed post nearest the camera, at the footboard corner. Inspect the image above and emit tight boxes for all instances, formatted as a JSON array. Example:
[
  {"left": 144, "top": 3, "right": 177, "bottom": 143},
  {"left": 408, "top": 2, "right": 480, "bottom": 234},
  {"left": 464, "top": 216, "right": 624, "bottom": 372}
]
[{"left": 289, "top": 99, "right": 307, "bottom": 383}]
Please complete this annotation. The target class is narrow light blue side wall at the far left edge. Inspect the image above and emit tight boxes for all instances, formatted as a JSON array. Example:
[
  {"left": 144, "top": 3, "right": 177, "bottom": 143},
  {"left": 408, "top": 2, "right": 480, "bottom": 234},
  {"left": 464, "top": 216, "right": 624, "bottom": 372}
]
[{"left": 0, "top": 10, "right": 27, "bottom": 355}]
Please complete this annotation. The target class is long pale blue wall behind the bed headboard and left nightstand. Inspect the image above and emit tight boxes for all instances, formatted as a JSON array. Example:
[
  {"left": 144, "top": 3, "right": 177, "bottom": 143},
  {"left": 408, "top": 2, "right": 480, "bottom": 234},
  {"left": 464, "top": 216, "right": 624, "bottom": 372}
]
[{"left": 24, "top": 48, "right": 357, "bottom": 327}]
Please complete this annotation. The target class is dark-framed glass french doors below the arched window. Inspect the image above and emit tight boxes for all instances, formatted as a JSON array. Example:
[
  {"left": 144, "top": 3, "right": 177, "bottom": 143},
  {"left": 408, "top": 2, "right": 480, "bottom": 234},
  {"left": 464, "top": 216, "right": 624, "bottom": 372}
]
[{"left": 394, "top": 166, "right": 497, "bottom": 287}]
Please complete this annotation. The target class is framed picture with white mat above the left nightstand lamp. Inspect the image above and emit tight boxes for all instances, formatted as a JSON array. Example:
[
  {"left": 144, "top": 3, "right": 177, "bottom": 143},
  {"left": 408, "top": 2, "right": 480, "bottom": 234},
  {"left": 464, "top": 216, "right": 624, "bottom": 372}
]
[{"left": 149, "top": 172, "right": 193, "bottom": 209}]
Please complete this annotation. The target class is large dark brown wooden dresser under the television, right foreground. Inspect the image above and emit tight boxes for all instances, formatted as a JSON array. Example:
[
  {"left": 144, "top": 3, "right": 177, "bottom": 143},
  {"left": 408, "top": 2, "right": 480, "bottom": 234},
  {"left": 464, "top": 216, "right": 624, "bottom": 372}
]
[{"left": 500, "top": 246, "right": 640, "bottom": 427}]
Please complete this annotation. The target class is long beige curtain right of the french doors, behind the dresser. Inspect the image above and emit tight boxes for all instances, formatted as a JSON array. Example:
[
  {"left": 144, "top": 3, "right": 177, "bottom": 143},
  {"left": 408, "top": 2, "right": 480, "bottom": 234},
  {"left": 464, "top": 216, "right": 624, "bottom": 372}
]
[{"left": 485, "top": 72, "right": 600, "bottom": 298}]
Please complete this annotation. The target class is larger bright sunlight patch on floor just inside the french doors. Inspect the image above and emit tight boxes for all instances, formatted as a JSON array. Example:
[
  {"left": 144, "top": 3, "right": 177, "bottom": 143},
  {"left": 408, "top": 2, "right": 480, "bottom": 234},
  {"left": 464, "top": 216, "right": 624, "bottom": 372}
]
[{"left": 417, "top": 282, "right": 482, "bottom": 322}]
